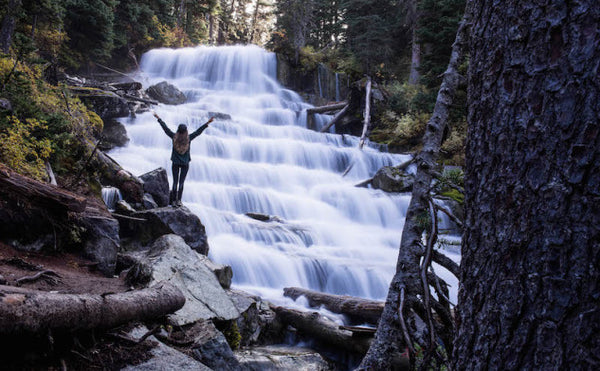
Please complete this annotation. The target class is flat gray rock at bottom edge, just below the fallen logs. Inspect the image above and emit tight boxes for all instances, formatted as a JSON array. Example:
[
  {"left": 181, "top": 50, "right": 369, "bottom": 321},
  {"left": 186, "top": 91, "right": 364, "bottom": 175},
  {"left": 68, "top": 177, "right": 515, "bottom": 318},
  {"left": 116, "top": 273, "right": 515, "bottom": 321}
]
[{"left": 236, "top": 345, "right": 334, "bottom": 371}]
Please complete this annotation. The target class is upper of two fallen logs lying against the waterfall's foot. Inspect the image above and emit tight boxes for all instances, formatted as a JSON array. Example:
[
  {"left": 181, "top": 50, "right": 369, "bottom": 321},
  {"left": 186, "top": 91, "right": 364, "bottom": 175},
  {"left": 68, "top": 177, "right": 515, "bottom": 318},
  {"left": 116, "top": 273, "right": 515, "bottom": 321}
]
[{"left": 283, "top": 287, "right": 385, "bottom": 324}]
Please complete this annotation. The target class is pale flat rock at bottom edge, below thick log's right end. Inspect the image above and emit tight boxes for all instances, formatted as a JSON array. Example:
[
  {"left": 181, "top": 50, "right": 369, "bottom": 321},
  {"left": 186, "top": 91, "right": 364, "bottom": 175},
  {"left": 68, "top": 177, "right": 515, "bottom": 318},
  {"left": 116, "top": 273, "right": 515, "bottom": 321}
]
[{"left": 122, "top": 326, "right": 211, "bottom": 371}]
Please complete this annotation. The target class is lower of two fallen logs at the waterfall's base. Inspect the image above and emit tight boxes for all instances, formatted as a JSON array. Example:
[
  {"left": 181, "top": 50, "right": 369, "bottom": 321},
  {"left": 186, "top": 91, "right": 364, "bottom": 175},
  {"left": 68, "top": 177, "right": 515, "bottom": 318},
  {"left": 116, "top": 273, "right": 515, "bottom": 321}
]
[{"left": 271, "top": 306, "right": 371, "bottom": 355}]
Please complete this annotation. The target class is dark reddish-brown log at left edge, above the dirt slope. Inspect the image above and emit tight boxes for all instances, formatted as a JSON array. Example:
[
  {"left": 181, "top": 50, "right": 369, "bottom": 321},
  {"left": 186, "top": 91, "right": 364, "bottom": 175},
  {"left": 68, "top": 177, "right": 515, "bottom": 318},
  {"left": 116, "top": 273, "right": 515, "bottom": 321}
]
[{"left": 0, "top": 164, "right": 86, "bottom": 213}]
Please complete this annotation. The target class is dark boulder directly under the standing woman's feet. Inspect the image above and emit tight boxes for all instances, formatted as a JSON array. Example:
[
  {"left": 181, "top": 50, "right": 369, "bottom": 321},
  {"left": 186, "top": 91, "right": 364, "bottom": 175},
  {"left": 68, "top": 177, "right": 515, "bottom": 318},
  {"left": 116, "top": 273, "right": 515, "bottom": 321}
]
[{"left": 121, "top": 206, "right": 208, "bottom": 255}]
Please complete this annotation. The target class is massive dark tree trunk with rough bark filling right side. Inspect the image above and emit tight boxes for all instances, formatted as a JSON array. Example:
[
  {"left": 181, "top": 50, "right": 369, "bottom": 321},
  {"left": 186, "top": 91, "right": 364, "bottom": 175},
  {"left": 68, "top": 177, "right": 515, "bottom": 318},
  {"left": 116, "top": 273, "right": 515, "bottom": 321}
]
[{"left": 454, "top": 0, "right": 600, "bottom": 370}]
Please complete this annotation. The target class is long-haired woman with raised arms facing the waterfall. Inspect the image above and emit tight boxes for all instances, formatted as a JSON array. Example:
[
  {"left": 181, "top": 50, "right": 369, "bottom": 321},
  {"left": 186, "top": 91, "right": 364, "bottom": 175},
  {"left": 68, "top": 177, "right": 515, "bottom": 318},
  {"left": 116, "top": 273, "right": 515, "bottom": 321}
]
[{"left": 153, "top": 113, "right": 215, "bottom": 206}]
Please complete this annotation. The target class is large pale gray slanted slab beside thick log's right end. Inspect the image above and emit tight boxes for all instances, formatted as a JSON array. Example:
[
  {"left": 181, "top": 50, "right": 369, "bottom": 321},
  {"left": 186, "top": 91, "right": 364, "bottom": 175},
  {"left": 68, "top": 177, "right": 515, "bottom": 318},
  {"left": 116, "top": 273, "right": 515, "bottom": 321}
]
[{"left": 148, "top": 235, "right": 240, "bottom": 325}]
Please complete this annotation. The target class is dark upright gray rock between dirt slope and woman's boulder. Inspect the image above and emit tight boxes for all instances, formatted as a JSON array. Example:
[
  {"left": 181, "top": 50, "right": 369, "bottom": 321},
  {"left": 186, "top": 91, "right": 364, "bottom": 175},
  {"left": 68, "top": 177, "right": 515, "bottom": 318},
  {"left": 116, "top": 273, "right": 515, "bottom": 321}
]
[{"left": 80, "top": 215, "right": 120, "bottom": 277}]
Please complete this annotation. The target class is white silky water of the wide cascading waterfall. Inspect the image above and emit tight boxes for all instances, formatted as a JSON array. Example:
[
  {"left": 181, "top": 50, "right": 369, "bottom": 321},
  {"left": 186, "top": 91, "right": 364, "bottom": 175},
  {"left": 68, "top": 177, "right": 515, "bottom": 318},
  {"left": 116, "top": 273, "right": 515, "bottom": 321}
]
[{"left": 111, "top": 46, "right": 455, "bottom": 308}]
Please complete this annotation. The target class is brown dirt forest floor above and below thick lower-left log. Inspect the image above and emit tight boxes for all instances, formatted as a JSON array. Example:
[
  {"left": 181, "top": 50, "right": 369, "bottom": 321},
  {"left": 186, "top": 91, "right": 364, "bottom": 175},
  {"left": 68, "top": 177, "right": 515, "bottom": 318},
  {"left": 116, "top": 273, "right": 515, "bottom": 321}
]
[{"left": 0, "top": 243, "right": 154, "bottom": 370}]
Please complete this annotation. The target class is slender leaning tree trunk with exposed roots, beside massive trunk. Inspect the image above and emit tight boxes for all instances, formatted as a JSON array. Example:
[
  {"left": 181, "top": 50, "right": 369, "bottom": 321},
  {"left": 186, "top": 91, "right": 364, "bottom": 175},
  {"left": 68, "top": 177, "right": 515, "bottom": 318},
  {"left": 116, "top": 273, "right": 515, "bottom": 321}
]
[{"left": 359, "top": 10, "right": 468, "bottom": 370}]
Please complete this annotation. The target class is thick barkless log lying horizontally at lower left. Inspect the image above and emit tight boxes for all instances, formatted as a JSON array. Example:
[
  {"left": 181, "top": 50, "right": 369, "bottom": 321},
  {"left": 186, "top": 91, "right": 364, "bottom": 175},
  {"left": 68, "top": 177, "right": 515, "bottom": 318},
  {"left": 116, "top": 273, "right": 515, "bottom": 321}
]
[{"left": 0, "top": 284, "right": 185, "bottom": 335}]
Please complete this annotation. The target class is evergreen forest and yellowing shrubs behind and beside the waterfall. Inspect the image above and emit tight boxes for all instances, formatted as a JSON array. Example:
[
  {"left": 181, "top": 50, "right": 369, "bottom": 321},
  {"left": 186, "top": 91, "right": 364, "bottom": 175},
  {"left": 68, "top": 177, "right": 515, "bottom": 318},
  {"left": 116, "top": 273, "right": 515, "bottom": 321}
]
[{"left": 0, "top": 0, "right": 466, "bottom": 182}]
